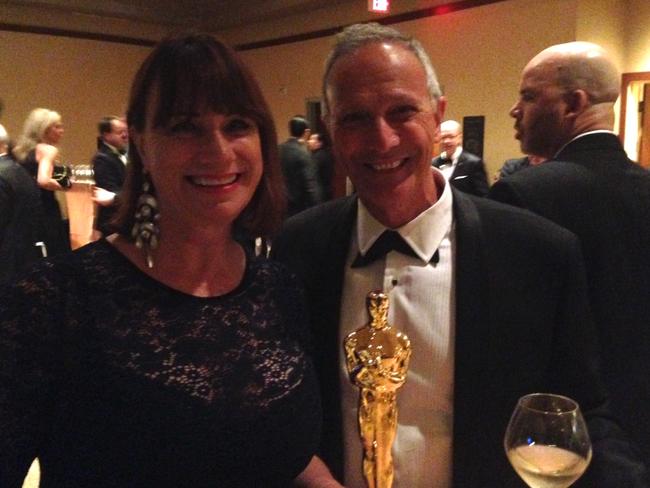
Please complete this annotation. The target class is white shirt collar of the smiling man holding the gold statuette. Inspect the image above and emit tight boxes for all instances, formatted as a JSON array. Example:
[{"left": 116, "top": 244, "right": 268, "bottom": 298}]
[{"left": 357, "top": 168, "right": 453, "bottom": 263}]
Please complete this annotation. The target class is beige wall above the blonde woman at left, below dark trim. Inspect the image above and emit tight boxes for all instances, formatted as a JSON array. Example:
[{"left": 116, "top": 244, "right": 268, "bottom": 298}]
[{"left": 0, "top": 32, "right": 149, "bottom": 164}]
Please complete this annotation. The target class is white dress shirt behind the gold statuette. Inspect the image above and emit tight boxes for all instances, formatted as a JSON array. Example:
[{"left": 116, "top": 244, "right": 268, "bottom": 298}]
[{"left": 339, "top": 168, "right": 455, "bottom": 488}]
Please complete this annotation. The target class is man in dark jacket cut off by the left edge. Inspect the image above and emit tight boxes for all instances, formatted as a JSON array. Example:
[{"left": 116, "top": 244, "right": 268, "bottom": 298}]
[{"left": 0, "top": 125, "right": 44, "bottom": 283}]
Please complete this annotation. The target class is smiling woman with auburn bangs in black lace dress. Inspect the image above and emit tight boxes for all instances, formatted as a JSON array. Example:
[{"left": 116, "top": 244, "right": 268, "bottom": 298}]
[{"left": 0, "top": 35, "right": 339, "bottom": 487}]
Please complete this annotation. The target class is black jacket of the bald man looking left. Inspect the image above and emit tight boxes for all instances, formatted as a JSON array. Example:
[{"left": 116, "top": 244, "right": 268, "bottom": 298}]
[{"left": 490, "top": 133, "right": 650, "bottom": 465}]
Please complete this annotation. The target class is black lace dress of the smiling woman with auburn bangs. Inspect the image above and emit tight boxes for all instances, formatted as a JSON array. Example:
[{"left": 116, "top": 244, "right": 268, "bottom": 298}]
[{"left": 0, "top": 240, "right": 320, "bottom": 488}]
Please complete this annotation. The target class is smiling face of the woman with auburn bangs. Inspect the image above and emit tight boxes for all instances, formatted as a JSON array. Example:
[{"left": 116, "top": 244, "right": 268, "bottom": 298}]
[{"left": 133, "top": 96, "right": 263, "bottom": 234}]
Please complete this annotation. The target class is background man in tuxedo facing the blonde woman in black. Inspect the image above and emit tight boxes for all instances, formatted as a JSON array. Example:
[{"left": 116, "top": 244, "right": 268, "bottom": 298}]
[{"left": 92, "top": 116, "right": 129, "bottom": 235}]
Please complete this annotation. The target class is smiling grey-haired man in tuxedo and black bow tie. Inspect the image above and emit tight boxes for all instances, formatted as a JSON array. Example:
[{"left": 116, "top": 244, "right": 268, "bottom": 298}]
[{"left": 272, "top": 24, "right": 643, "bottom": 488}]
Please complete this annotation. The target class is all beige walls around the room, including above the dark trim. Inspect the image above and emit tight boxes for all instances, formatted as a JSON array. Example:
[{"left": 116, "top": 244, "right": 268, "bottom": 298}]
[{"left": 0, "top": 0, "right": 650, "bottom": 181}]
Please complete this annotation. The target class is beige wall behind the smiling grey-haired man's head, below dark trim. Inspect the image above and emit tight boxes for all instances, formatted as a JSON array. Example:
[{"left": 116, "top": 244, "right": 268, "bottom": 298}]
[{"left": 244, "top": 0, "right": 575, "bottom": 179}]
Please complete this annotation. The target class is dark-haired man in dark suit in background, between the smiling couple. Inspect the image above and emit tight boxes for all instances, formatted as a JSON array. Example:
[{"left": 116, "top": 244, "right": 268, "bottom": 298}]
[{"left": 280, "top": 116, "right": 321, "bottom": 217}]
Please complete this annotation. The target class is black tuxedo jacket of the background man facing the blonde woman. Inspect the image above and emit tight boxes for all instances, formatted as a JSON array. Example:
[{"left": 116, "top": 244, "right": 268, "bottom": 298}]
[{"left": 92, "top": 142, "right": 126, "bottom": 235}]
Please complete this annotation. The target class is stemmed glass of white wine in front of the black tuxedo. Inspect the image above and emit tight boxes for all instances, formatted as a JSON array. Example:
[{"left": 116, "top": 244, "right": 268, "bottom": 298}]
[{"left": 504, "top": 393, "right": 591, "bottom": 488}]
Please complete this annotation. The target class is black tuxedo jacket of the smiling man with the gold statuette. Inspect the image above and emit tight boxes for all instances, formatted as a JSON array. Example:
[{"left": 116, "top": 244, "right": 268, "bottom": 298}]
[{"left": 272, "top": 191, "right": 644, "bottom": 488}]
